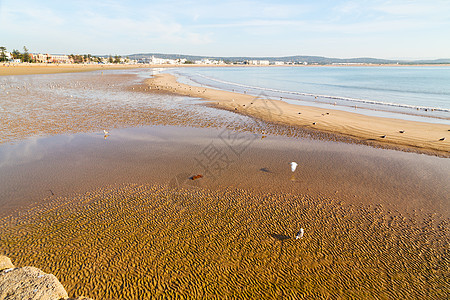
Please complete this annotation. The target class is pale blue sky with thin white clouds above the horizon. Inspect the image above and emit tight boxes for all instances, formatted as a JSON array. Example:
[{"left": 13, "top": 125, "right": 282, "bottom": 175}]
[{"left": 0, "top": 0, "right": 450, "bottom": 59}]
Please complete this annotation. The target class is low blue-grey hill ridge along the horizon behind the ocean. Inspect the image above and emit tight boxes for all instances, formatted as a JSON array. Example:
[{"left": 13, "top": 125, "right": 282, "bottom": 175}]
[{"left": 127, "top": 53, "right": 450, "bottom": 65}]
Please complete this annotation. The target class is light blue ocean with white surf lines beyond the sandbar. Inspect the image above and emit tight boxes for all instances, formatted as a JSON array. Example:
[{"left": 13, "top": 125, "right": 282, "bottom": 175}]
[{"left": 169, "top": 66, "right": 450, "bottom": 124}]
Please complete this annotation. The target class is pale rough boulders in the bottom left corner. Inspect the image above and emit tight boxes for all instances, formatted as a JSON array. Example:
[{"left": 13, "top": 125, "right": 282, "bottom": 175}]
[{"left": 0, "top": 256, "right": 92, "bottom": 300}]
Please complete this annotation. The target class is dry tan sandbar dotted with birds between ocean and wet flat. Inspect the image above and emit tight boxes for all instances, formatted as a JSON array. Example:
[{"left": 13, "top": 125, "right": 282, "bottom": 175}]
[{"left": 145, "top": 74, "right": 450, "bottom": 157}]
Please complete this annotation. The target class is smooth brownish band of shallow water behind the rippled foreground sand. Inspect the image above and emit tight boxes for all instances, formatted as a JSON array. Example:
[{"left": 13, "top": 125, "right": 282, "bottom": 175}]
[{"left": 0, "top": 126, "right": 450, "bottom": 218}]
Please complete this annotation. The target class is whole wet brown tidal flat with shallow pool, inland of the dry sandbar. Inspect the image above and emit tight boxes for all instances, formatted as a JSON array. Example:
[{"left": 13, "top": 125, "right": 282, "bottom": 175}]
[{"left": 0, "top": 69, "right": 450, "bottom": 299}]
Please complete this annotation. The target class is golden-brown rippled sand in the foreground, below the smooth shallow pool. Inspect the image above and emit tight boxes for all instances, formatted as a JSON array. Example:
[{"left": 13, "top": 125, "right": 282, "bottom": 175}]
[{"left": 0, "top": 185, "right": 449, "bottom": 299}]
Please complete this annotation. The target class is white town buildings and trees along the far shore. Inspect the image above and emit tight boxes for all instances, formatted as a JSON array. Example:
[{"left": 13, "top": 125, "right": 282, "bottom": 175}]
[{"left": 0, "top": 47, "right": 308, "bottom": 66}]
